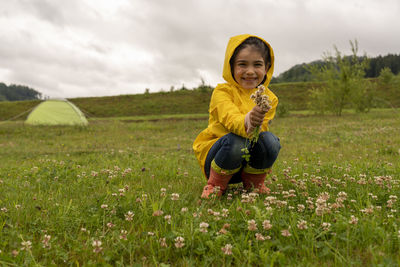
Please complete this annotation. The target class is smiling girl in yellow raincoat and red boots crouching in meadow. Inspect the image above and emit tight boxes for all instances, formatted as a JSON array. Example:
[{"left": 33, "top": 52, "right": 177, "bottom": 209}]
[{"left": 193, "top": 34, "right": 281, "bottom": 198}]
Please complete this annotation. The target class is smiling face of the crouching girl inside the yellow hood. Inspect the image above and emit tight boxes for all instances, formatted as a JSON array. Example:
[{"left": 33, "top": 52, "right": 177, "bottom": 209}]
[{"left": 233, "top": 46, "right": 268, "bottom": 89}]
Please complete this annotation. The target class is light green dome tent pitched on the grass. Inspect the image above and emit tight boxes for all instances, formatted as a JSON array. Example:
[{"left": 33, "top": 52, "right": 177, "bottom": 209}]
[{"left": 25, "top": 99, "right": 88, "bottom": 125}]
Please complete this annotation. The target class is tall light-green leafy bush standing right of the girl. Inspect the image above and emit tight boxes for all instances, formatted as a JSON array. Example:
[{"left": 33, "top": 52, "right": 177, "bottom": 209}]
[{"left": 308, "top": 40, "right": 373, "bottom": 116}]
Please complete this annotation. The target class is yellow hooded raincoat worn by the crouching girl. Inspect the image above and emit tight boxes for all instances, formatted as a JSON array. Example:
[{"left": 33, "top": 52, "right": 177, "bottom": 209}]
[{"left": 193, "top": 34, "right": 278, "bottom": 178}]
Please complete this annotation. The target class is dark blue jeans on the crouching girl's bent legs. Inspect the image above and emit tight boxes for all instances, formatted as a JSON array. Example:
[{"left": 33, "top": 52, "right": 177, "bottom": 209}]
[{"left": 204, "top": 132, "right": 281, "bottom": 183}]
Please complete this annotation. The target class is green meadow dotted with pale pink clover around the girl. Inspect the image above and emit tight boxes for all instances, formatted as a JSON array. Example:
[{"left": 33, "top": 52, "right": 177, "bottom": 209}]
[{"left": 0, "top": 109, "right": 400, "bottom": 266}]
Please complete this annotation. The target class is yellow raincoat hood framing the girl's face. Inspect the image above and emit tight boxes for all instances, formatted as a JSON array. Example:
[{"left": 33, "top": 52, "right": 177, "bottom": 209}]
[{"left": 222, "top": 34, "right": 274, "bottom": 87}]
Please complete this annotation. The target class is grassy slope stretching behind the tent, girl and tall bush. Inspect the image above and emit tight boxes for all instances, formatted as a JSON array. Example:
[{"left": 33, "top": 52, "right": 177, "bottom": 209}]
[{"left": 0, "top": 80, "right": 400, "bottom": 121}]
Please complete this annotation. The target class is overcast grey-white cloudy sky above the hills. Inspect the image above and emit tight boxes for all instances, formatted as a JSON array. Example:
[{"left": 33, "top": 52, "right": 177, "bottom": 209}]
[{"left": 0, "top": 0, "right": 400, "bottom": 98}]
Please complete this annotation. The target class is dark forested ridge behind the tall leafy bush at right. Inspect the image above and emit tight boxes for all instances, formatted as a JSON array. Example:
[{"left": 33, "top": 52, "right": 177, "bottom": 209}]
[{"left": 271, "top": 54, "right": 400, "bottom": 83}]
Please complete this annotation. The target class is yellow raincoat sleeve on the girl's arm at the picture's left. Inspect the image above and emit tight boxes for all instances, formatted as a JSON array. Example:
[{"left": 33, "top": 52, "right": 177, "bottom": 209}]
[{"left": 210, "top": 87, "right": 247, "bottom": 137}]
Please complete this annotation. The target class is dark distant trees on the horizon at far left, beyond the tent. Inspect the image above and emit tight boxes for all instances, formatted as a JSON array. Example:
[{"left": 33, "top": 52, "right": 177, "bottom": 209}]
[{"left": 0, "top": 83, "right": 42, "bottom": 101}]
